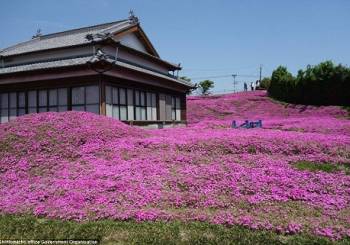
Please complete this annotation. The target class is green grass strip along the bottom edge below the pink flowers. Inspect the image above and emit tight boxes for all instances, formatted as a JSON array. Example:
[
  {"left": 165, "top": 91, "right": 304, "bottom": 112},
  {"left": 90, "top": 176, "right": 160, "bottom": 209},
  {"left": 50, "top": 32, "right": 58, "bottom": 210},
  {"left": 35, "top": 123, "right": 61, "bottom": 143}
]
[{"left": 0, "top": 215, "right": 350, "bottom": 244}]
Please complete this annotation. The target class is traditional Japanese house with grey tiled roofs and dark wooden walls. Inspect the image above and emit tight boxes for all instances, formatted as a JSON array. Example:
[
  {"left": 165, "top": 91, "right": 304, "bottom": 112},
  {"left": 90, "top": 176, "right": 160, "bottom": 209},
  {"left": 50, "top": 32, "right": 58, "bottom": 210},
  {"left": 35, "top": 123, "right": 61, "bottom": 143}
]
[{"left": 0, "top": 14, "right": 193, "bottom": 127}]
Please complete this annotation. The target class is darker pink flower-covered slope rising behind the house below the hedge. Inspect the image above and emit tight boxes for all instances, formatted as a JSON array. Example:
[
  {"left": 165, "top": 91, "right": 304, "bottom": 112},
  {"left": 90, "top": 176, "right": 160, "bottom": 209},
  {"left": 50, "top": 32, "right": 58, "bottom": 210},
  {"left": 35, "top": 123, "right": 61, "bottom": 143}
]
[{"left": 188, "top": 90, "right": 347, "bottom": 122}]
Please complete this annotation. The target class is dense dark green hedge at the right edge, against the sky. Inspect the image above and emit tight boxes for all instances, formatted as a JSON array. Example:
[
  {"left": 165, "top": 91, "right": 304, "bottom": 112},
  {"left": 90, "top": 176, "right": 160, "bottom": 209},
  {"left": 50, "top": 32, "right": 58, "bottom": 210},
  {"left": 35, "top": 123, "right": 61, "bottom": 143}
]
[{"left": 266, "top": 61, "right": 350, "bottom": 106}]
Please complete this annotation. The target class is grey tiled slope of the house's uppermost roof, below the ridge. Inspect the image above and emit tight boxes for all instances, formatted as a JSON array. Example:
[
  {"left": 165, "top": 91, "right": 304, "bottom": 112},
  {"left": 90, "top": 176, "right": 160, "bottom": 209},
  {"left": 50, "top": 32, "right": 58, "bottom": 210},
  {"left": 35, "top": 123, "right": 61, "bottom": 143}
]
[{"left": 0, "top": 20, "right": 135, "bottom": 56}]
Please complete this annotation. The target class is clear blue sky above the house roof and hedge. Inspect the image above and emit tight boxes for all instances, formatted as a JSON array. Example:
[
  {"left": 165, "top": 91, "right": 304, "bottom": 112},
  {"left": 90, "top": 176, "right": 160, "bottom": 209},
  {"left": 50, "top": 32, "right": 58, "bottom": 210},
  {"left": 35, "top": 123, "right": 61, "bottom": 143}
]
[{"left": 0, "top": 0, "right": 350, "bottom": 91}]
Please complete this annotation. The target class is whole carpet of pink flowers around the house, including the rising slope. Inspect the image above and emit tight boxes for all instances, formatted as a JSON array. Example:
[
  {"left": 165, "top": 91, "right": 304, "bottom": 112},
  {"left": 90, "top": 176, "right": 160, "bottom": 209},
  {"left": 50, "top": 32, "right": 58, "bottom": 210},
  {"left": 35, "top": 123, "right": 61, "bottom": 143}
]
[{"left": 0, "top": 91, "right": 350, "bottom": 239}]
